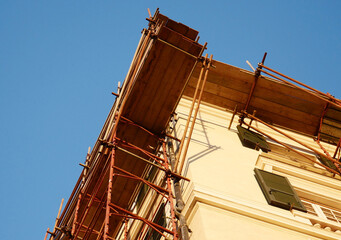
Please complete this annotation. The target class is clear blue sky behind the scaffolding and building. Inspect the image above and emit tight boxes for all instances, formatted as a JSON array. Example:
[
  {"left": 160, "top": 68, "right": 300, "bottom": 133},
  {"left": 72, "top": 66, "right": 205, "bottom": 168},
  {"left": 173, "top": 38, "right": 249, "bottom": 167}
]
[{"left": 0, "top": 0, "right": 341, "bottom": 240}]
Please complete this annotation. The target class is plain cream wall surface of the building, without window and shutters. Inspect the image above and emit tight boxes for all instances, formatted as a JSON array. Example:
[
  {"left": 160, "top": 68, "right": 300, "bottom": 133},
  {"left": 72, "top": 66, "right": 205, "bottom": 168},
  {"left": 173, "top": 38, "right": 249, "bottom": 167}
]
[{"left": 175, "top": 99, "right": 341, "bottom": 240}]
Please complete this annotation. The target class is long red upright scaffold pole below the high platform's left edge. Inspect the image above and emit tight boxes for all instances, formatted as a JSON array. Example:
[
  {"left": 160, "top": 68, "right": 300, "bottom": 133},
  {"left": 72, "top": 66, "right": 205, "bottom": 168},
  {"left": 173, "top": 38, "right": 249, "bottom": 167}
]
[{"left": 104, "top": 147, "right": 116, "bottom": 240}]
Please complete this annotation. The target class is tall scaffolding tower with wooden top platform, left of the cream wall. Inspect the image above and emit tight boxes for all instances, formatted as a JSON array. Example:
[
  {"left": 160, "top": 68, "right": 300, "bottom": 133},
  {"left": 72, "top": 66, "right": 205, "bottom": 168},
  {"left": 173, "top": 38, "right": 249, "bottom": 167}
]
[{"left": 45, "top": 10, "right": 209, "bottom": 240}]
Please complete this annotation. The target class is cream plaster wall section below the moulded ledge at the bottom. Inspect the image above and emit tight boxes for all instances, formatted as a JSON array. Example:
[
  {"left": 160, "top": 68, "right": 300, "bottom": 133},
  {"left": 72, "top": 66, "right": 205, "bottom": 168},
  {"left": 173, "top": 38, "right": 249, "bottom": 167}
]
[{"left": 191, "top": 203, "right": 321, "bottom": 240}]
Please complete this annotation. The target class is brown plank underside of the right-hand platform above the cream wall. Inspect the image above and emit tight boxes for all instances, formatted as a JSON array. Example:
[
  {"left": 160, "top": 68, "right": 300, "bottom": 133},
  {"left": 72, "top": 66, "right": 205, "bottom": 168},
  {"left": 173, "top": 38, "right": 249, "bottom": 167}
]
[{"left": 184, "top": 61, "right": 341, "bottom": 144}]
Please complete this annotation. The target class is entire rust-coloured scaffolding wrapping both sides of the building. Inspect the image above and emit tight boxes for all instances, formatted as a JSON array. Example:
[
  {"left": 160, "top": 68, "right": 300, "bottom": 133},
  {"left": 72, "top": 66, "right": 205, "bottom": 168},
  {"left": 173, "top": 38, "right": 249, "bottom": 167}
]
[{"left": 45, "top": 10, "right": 341, "bottom": 240}]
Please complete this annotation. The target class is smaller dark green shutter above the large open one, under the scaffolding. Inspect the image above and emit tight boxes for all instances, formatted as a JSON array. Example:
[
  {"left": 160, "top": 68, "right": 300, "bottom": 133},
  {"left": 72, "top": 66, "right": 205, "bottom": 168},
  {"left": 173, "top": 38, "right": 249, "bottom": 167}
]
[{"left": 237, "top": 125, "right": 270, "bottom": 152}]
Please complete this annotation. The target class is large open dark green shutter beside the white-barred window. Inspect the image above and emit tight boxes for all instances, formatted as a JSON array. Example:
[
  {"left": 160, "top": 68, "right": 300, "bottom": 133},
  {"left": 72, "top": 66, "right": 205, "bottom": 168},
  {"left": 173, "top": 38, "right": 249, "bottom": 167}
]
[{"left": 254, "top": 168, "right": 307, "bottom": 212}]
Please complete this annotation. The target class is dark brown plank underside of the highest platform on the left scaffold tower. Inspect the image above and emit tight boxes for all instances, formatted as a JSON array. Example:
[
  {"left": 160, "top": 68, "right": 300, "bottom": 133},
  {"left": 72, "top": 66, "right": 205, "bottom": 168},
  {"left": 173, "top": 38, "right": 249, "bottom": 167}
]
[{"left": 124, "top": 26, "right": 201, "bottom": 131}]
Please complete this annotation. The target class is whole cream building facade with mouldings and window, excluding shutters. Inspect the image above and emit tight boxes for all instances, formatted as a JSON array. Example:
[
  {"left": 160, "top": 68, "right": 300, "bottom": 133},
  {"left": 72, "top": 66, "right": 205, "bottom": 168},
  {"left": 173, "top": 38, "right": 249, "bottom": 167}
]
[{"left": 175, "top": 99, "right": 341, "bottom": 239}]
